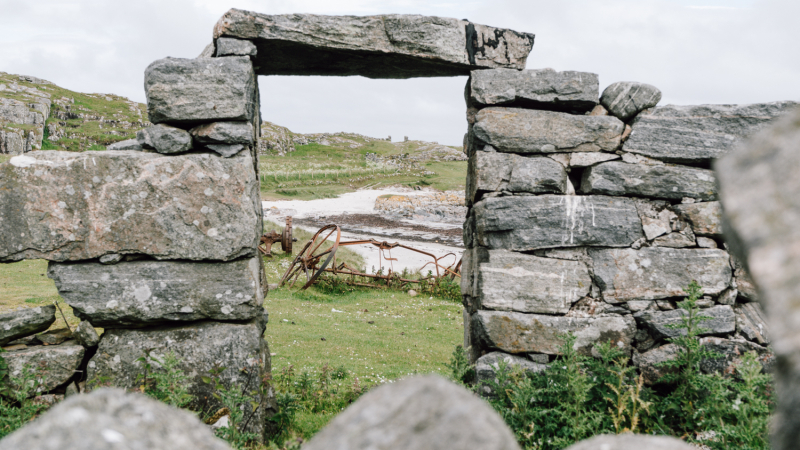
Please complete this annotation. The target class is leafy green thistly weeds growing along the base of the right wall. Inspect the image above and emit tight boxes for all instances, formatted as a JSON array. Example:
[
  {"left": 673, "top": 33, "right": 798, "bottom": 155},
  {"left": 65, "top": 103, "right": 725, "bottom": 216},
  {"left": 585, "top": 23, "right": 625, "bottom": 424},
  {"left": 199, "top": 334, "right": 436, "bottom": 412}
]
[{"left": 462, "top": 282, "right": 774, "bottom": 450}]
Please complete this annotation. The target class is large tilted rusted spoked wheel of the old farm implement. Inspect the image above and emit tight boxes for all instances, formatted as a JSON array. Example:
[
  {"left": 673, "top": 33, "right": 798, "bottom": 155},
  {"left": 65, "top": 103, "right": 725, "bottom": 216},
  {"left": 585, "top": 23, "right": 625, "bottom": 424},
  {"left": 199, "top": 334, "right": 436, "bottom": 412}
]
[{"left": 281, "top": 225, "right": 342, "bottom": 290}]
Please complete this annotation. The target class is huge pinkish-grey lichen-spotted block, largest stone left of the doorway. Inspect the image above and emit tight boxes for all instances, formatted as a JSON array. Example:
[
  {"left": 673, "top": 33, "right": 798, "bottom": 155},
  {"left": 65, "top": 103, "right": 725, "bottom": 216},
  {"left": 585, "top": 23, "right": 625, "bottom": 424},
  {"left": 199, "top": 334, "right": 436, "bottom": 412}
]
[{"left": 0, "top": 151, "right": 262, "bottom": 261}]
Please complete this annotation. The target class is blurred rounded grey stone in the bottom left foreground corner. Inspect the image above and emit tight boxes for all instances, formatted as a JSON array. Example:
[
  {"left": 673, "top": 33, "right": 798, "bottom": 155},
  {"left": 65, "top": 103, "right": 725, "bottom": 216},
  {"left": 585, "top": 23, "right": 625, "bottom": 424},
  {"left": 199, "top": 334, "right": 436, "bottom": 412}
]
[{"left": 0, "top": 389, "right": 230, "bottom": 450}]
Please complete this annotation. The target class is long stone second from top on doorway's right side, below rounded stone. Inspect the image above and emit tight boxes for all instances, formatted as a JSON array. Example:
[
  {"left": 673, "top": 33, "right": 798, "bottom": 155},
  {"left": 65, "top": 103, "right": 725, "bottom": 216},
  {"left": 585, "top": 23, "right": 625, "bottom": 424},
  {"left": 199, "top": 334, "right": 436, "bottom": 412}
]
[{"left": 473, "top": 107, "right": 625, "bottom": 153}]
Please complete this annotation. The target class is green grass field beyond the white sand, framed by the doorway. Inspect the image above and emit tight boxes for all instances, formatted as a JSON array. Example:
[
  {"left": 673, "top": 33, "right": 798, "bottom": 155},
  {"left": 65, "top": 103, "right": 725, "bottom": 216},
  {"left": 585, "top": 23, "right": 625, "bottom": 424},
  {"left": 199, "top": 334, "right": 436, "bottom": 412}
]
[{"left": 259, "top": 137, "right": 467, "bottom": 200}]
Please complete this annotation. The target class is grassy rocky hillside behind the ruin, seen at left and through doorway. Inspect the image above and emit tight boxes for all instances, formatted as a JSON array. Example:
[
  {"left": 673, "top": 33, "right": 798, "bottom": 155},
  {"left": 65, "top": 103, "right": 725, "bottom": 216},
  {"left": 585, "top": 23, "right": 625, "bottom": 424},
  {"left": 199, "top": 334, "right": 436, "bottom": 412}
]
[{"left": 0, "top": 72, "right": 467, "bottom": 199}]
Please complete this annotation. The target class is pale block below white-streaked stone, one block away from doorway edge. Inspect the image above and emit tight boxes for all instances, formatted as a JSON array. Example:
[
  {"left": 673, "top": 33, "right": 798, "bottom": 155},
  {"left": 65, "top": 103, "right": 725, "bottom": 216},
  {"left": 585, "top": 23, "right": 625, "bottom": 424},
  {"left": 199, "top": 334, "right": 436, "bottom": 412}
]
[{"left": 589, "top": 247, "right": 732, "bottom": 302}]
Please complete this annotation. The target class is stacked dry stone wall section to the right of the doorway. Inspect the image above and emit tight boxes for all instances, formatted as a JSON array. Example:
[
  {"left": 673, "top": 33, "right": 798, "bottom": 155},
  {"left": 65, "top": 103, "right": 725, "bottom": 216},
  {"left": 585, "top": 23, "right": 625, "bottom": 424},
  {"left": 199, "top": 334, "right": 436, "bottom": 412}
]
[{"left": 461, "top": 69, "right": 795, "bottom": 384}]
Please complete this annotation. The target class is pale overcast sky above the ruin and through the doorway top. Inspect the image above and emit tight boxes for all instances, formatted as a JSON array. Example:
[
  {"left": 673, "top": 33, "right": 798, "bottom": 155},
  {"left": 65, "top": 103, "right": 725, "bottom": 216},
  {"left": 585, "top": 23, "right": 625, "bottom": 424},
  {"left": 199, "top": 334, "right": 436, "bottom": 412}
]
[{"left": 0, "top": 0, "right": 800, "bottom": 145}]
